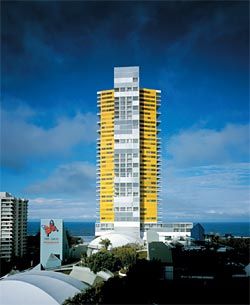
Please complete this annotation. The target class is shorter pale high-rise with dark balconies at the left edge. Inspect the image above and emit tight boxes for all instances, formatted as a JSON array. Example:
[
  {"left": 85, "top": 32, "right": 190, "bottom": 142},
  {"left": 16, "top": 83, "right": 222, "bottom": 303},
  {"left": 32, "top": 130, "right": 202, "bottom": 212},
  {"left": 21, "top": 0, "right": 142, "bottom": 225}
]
[{"left": 0, "top": 192, "right": 28, "bottom": 261}]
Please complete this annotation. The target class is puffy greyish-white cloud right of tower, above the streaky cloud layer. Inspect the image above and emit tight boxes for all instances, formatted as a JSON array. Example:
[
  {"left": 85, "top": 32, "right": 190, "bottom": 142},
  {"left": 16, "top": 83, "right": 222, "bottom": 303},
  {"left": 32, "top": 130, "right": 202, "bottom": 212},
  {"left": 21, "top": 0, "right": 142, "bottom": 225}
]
[{"left": 168, "top": 124, "right": 250, "bottom": 166}]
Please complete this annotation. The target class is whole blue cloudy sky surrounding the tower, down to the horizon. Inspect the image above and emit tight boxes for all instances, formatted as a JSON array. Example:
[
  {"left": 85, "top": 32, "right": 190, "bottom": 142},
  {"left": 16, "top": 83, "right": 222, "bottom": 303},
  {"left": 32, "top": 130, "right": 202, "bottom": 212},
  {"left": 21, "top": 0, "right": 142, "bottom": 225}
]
[{"left": 1, "top": 1, "right": 250, "bottom": 221}]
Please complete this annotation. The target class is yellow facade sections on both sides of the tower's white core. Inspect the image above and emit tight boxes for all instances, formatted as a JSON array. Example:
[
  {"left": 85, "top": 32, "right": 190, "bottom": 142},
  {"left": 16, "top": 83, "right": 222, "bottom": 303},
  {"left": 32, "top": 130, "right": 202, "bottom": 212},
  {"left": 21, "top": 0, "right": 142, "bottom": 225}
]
[{"left": 98, "top": 89, "right": 159, "bottom": 223}]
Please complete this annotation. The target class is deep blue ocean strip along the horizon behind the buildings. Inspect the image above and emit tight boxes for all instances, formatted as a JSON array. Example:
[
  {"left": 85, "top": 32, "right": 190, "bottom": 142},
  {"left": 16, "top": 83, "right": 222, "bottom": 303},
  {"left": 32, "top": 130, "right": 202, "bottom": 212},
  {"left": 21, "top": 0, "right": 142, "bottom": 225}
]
[{"left": 28, "top": 221, "right": 250, "bottom": 241}]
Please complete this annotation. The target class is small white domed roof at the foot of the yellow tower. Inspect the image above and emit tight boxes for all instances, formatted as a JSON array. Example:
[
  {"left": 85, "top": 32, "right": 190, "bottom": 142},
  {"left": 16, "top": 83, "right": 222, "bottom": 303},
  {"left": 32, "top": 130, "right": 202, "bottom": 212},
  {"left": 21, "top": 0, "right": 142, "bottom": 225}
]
[{"left": 88, "top": 233, "right": 143, "bottom": 249}]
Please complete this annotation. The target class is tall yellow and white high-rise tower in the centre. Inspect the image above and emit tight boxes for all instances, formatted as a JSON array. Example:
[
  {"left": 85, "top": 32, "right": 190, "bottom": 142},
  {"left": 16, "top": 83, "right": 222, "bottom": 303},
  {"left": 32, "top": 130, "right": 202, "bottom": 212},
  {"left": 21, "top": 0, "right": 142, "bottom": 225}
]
[{"left": 96, "top": 67, "right": 161, "bottom": 236}]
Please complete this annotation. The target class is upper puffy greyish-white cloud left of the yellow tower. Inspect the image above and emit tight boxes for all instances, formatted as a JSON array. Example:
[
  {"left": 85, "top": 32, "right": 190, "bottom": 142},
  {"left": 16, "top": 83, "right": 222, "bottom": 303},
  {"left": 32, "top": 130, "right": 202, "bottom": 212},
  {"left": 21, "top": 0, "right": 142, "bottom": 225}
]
[{"left": 1, "top": 106, "right": 96, "bottom": 168}]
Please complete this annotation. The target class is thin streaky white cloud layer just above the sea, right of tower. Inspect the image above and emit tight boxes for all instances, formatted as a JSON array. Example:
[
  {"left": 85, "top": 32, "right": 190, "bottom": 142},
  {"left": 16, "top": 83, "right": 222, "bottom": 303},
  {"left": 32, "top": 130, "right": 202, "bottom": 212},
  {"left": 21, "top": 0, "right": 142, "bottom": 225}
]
[{"left": 162, "top": 163, "right": 250, "bottom": 221}]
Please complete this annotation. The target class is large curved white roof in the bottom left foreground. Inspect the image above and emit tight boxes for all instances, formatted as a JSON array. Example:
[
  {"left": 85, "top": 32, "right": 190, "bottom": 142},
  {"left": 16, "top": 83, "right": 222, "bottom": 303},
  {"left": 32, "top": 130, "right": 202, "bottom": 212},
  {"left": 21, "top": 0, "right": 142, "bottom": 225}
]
[{"left": 0, "top": 271, "right": 88, "bottom": 305}]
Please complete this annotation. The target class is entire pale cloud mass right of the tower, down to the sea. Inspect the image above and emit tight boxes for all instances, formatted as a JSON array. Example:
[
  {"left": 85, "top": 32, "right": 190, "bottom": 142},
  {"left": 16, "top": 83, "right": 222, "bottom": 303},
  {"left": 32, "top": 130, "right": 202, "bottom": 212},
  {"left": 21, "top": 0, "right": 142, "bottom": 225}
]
[{"left": 162, "top": 124, "right": 250, "bottom": 221}]
